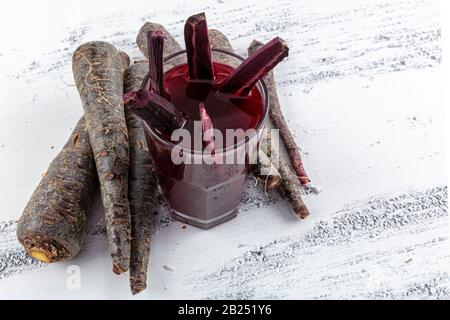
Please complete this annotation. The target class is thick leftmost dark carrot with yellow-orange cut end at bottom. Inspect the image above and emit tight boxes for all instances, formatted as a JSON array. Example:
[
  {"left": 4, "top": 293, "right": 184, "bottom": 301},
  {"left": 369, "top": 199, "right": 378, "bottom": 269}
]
[{"left": 17, "top": 118, "right": 97, "bottom": 263}]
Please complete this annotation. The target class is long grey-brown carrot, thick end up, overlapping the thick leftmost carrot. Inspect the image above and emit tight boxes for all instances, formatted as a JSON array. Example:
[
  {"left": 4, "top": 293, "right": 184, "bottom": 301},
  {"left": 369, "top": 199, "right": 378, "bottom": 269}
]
[{"left": 72, "top": 41, "right": 131, "bottom": 274}]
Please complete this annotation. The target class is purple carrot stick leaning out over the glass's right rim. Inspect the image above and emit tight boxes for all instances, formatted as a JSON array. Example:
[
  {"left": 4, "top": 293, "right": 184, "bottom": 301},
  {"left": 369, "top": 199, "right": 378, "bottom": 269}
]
[{"left": 219, "top": 37, "right": 289, "bottom": 96}]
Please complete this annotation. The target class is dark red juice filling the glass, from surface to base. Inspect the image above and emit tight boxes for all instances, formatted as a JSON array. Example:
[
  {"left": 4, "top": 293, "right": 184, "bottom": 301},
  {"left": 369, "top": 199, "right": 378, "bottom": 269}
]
[{"left": 142, "top": 62, "right": 265, "bottom": 228}]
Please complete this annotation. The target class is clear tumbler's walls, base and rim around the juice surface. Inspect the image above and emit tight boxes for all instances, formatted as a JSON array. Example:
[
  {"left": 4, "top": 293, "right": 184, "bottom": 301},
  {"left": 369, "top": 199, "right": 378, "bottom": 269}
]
[{"left": 142, "top": 49, "right": 269, "bottom": 229}]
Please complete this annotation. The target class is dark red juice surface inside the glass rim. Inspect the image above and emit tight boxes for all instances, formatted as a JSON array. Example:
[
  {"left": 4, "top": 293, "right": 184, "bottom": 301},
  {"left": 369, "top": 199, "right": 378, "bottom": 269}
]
[{"left": 164, "top": 62, "right": 264, "bottom": 146}]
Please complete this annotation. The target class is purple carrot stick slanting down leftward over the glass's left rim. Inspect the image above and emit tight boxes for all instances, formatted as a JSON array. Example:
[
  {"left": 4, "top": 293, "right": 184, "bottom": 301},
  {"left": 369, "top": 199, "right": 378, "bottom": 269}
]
[{"left": 123, "top": 90, "right": 186, "bottom": 134}]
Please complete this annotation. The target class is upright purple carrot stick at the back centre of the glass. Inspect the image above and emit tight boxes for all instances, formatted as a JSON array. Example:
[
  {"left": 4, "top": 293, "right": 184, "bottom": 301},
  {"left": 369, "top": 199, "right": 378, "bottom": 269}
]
[{"left": 184, "top": 12, "right": 214, "bottom": 80}]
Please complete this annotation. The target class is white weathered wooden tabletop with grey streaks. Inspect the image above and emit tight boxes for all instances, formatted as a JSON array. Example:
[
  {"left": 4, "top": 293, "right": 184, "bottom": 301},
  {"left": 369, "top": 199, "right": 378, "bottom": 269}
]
[{"left": 0, "top": 0, "right": 450, "bottom": 299}]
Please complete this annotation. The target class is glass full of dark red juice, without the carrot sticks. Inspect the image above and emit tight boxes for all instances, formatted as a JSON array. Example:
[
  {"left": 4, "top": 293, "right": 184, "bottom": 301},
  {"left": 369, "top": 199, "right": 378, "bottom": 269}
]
[{"left": 142, "top": 49, "right": 268, "bottom": 229}]
